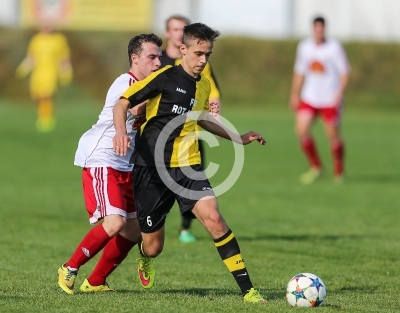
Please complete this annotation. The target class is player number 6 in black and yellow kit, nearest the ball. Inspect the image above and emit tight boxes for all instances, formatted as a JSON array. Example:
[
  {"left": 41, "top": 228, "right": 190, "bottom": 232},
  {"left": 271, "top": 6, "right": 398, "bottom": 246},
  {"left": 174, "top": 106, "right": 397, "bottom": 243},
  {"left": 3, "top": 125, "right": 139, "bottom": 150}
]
[{"left": 113, "top": 23, "right": 266, "bottom": 303}]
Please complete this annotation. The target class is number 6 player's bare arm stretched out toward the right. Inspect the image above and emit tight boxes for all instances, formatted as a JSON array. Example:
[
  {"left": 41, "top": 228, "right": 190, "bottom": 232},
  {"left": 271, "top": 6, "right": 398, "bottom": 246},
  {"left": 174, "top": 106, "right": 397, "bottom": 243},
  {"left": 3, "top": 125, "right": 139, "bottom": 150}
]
[{"left": 198, "top": 112, "right": 266, "bottom": 145}]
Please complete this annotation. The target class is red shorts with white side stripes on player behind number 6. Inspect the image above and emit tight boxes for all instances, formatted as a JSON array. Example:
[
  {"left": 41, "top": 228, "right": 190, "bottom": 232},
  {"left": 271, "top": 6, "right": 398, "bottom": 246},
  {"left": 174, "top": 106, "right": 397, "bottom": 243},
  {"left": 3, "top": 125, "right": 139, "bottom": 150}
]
[{"left": 82, "top": 167, "right": 136, "bottom": 224}]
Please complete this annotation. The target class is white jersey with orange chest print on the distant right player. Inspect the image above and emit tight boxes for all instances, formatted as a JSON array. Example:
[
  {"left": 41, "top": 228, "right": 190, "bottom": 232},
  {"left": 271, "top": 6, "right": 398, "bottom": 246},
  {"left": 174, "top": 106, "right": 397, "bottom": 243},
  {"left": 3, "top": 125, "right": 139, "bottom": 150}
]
[{"left": 294, "top": 38, "right": 350, "bottom": 108}]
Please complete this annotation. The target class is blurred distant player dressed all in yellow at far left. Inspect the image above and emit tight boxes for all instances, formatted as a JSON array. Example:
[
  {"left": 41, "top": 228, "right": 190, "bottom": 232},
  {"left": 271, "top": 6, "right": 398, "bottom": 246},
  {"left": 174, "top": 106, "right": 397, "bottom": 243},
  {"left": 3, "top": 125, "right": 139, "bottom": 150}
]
[{"left": 16, "top": 24, "right": 72, "bottom": 133}]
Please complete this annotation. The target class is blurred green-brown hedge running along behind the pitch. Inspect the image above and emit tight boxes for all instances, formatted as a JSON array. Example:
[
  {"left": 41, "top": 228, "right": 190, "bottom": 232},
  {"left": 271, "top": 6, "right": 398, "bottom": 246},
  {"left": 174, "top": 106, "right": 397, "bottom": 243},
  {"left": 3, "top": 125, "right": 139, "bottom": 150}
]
[{"left": 0, "top": 29, "right": 400, "bottom": 111}]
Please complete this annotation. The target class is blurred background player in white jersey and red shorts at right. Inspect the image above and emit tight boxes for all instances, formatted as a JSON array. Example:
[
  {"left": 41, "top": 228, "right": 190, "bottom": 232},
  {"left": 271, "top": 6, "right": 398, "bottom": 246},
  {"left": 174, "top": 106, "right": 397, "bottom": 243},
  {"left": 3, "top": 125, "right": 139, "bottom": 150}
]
[{"left": 290, "top": 17, "right": 350, "bottom": 184}]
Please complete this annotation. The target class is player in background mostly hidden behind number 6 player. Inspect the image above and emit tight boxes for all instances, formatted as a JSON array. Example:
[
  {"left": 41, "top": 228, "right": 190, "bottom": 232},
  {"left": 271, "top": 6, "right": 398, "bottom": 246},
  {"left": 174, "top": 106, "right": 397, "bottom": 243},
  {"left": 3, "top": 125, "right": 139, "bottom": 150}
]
[{"left": 161, "top": 15, "right": 221, "bottom": 243}]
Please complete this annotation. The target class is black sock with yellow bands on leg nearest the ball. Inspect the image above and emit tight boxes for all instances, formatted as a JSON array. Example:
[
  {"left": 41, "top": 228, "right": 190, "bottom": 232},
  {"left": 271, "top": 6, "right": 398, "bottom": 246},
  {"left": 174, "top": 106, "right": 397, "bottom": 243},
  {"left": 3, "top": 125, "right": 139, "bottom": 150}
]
[{"left": 214, "top": 230, "right": 253, "bottom": 295}]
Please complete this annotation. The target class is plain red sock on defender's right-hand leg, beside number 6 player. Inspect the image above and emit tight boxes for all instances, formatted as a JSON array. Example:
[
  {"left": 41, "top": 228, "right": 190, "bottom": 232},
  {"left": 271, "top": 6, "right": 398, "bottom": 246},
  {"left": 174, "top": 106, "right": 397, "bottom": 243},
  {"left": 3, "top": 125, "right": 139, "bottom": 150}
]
[{"left": 88, "top": 234, "right": 136, "bottom": 286}]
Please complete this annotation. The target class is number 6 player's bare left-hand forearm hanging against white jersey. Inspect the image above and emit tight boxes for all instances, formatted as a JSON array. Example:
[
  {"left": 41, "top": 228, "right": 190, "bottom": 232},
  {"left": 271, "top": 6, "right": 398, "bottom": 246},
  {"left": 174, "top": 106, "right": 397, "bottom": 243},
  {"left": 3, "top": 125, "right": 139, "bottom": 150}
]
[{"left": 113, "top": 98, "right": 130, "bottom": 156}]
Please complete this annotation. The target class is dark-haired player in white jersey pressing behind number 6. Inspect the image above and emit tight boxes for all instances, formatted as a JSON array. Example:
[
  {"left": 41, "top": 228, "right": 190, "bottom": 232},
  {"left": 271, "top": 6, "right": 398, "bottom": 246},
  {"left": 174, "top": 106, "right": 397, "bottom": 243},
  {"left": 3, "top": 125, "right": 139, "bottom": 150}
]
[{"left": 58, "top": 34, "right": 162, "bottom": 294}]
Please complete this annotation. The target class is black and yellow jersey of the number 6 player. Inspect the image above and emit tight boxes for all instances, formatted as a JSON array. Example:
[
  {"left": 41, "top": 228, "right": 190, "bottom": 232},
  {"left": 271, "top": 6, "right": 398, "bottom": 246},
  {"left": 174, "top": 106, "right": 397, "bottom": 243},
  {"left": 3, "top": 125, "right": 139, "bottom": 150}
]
[{"left": 121, "top": 65, "right": 211, "bottom": 167}]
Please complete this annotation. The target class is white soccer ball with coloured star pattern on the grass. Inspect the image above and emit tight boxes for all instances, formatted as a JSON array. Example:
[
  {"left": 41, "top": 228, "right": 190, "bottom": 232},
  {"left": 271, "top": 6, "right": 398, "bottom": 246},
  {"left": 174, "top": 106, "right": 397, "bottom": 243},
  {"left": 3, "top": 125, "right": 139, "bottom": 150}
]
[{"left": 286, "top": 273, "right": 326, "bottom": 307}]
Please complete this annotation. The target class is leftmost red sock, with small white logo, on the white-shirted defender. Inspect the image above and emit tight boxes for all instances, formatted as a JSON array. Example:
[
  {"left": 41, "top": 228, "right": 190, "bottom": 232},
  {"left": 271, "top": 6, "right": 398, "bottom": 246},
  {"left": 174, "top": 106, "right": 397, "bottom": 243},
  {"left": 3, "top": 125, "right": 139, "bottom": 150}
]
[{"left": 65, "top": 224, "right": 111, "bottom": 269}]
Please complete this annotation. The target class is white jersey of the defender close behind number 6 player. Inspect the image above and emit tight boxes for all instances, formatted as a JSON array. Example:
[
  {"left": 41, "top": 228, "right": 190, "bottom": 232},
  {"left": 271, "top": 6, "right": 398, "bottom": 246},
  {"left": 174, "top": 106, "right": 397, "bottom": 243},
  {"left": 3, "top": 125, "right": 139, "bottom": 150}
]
[{"left": 74, "top": 73, "right": 141, "bottom": 172}]
